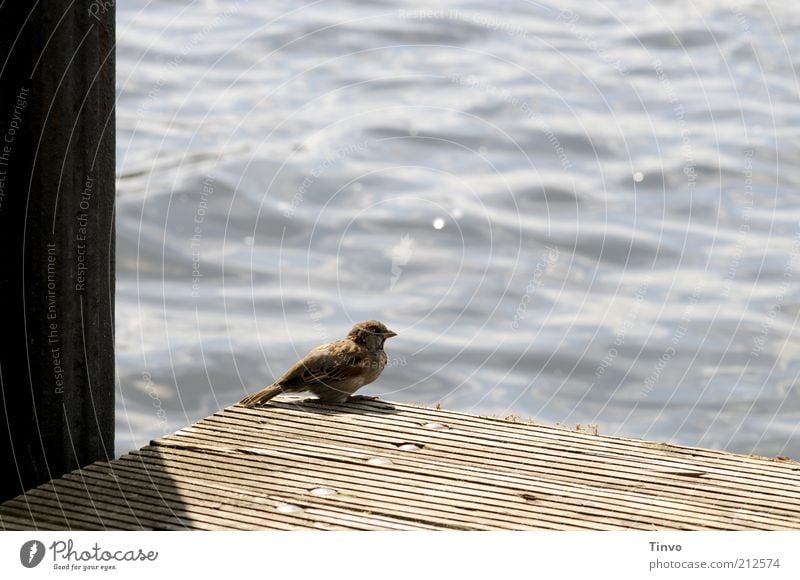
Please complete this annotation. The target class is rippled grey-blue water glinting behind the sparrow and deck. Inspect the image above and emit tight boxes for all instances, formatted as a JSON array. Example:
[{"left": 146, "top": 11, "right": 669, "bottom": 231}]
[{"left": 116, "top": 0, "right": 800, "bottom": 457}]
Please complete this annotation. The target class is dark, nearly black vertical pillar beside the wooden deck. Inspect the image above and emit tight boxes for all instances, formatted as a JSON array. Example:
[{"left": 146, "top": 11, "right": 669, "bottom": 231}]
[{"left": 0, "top": 0, "right": 115, "bottom": 500}]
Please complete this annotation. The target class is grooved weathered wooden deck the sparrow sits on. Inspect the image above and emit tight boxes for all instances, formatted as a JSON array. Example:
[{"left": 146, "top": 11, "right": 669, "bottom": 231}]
[{"left": 0, "top": 399, "right": 800, "bottom": 530}]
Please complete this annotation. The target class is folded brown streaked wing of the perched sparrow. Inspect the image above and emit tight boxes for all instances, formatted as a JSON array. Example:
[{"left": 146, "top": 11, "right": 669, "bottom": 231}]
[{"left": 275, "top": 341, "right": 367, "bottom": 388}]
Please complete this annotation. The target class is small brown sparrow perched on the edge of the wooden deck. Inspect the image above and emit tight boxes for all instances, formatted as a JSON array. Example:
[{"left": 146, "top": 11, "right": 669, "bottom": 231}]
[{"left": 239, "top": 320, "right": 397, "bottom": 407}]
